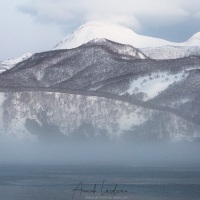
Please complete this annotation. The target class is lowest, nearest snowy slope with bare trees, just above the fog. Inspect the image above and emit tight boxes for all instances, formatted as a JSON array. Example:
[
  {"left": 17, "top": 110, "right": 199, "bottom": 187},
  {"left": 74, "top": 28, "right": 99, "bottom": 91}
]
[{"left": 0, "top": 91, "right": 200, "bottom": 142}]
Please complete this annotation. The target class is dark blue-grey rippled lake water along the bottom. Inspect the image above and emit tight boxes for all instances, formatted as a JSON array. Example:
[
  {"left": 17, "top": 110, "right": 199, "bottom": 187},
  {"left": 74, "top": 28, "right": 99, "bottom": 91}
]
[{"left": 0, "top": 165, "right": 200, "bottom": 200}]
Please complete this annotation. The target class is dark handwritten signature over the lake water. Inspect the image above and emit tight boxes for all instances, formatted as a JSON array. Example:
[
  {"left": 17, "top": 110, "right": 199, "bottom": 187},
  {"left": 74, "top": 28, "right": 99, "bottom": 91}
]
[{"left": 72, "top": 180, "right": 128, "bottom": 199}]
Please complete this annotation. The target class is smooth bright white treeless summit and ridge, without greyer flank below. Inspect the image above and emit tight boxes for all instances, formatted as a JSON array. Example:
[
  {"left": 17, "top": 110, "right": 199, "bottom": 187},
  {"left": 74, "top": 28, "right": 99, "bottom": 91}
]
[{"left": 54, "top": 22, "right": 200, "bottom": 49}]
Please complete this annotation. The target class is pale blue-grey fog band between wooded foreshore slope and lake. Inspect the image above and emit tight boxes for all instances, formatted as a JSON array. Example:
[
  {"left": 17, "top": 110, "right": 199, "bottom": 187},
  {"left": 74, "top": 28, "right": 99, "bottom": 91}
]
[{"left": 0, "top": 133, "right": 200, "bottom": 167}]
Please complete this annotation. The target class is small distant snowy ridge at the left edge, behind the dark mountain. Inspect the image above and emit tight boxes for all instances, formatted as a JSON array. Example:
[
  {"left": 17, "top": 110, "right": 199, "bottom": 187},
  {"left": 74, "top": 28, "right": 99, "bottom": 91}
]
[{"left": 0, "top": 52, "right": 32, "bottom": 73}]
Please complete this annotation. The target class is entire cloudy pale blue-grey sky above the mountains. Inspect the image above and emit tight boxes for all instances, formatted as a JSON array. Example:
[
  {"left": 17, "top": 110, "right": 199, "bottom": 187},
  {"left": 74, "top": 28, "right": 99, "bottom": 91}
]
[{"left": 0, "top": 0, "right": 200, "bottom": 60}]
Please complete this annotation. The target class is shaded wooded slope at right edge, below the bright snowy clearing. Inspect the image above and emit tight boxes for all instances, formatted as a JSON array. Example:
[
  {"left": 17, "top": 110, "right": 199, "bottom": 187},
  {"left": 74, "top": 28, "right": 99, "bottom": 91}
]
[{"left": 148, "top": 67, "right": 200, "bottom": 122}]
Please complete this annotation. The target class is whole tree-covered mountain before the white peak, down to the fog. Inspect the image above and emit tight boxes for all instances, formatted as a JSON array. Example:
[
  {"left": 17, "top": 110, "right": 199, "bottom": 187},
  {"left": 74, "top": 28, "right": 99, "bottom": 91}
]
[{"left": 0, "top": 39, "right": 200, "bottom": 141}]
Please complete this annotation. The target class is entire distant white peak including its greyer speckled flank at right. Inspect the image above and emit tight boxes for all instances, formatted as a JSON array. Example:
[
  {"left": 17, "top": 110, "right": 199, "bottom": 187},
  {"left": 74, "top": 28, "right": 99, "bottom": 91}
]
[{"left": 54, "top": 22, "right": 200, "bottom": 59}]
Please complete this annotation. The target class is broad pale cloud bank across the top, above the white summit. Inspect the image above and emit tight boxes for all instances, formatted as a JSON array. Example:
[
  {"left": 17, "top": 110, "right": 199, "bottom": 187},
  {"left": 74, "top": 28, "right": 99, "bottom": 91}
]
[{"left": 19, "top": 0, "right": 199, "bottom": 29}]
